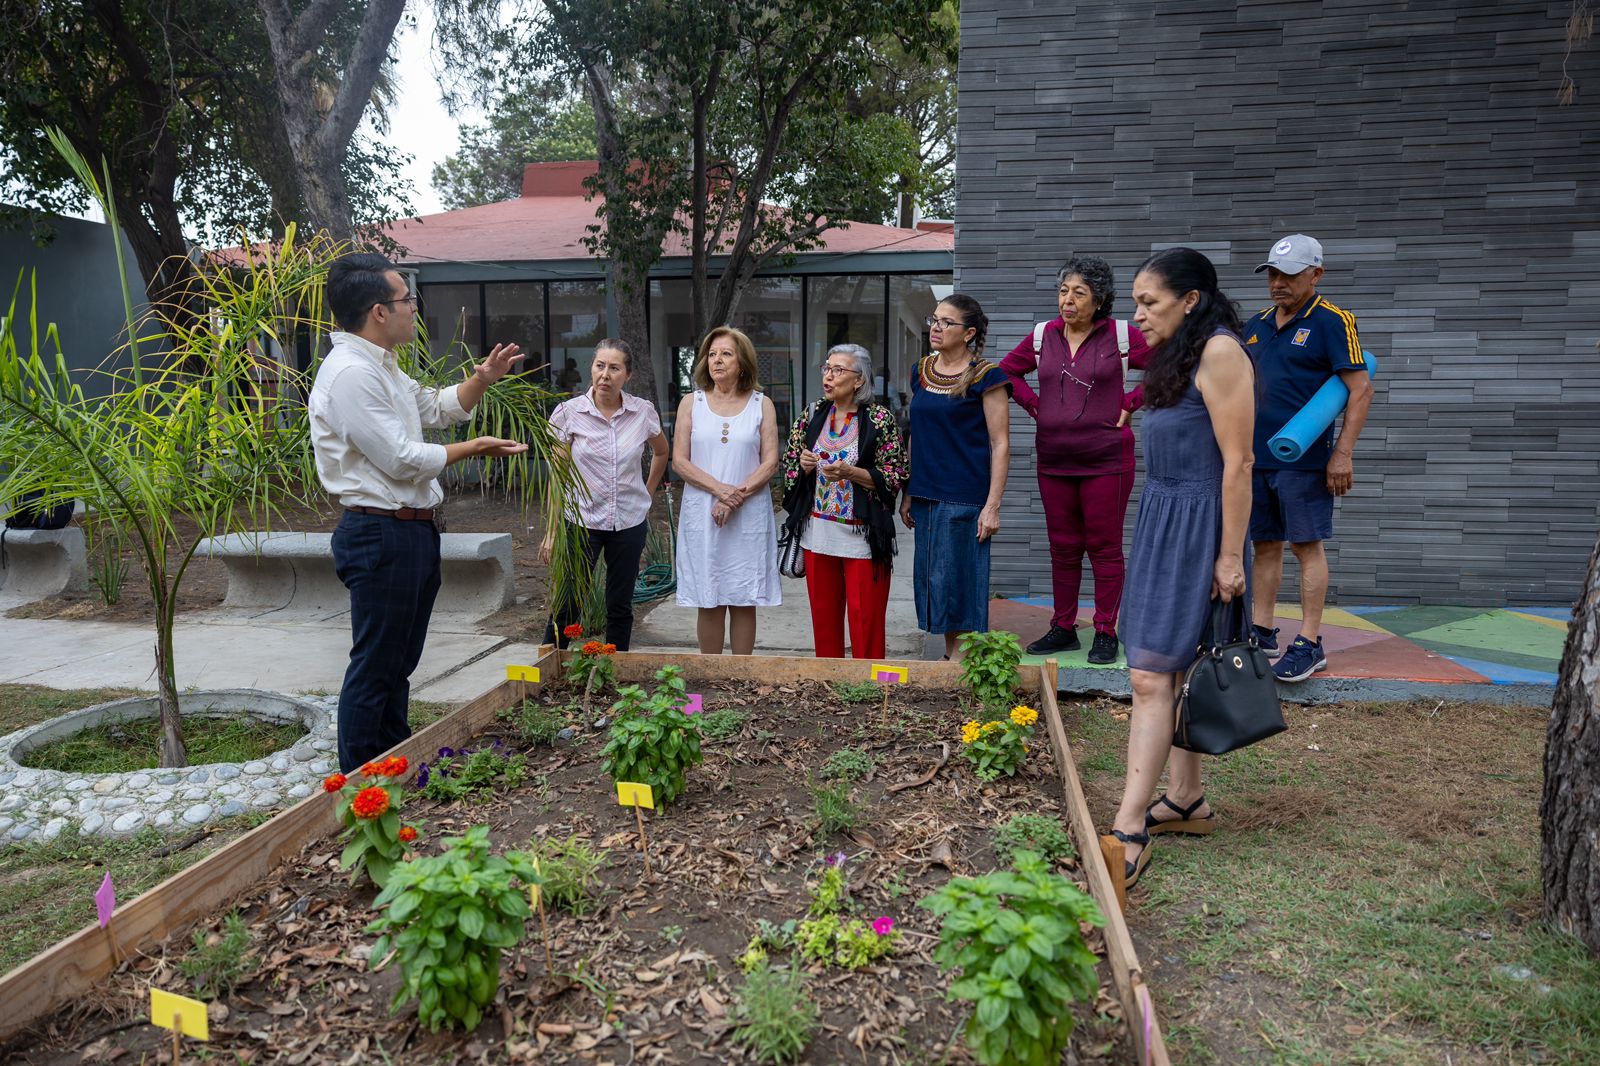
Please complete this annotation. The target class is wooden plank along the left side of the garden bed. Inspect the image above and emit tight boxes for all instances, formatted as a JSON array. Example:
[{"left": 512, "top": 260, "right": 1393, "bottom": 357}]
[{"left": 0, "top": 655, "right": 560, "bottom": 1040}]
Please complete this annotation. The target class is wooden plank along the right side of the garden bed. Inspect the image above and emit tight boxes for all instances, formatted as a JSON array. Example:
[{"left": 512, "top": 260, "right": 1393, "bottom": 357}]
[{"left": 1038, "top": 659, "right": 1171, "bottom": 1066}]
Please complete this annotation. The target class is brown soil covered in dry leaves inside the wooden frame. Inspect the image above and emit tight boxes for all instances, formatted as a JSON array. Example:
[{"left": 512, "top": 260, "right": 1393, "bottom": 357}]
[{"left": 0, "top": 682, "right": 1130, "bottom": 1064}]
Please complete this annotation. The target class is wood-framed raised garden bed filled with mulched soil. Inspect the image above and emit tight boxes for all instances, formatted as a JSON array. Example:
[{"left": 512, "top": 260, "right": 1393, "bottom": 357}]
[{"left": 0, "top": 655, "right": 1165, "bottom": 1063}]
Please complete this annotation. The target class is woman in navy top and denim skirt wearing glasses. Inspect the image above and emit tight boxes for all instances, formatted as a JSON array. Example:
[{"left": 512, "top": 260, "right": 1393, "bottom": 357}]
[{"left": 901, "top": 293, "right": 1011, "bottom": 658}]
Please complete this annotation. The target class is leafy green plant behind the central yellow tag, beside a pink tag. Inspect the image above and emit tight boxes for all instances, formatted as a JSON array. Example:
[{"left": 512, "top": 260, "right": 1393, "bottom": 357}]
[{"left": 600, "top": 666, "right": 702, "bottom": 807}]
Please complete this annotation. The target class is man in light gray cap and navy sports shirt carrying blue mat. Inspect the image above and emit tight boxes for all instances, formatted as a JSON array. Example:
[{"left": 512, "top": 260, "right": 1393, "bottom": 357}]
[{"left": 1245, "top": 234, "right": 1373, "bottom": 682}]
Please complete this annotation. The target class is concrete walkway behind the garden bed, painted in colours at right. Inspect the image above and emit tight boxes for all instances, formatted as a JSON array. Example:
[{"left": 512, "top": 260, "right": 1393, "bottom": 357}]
[{"left": 0, "top": 582, "right": 1570, "bottom": 706}]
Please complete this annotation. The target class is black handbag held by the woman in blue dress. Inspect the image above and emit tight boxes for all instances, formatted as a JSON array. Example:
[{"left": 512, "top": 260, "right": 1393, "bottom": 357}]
[{"left": 1173, "top": 595, "right": 1288, "bottom": 755}]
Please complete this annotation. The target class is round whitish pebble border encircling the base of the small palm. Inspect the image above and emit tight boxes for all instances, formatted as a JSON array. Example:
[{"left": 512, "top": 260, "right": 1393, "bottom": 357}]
[{"left": 0, "top": 690, "right": 339, "bottom": 842}]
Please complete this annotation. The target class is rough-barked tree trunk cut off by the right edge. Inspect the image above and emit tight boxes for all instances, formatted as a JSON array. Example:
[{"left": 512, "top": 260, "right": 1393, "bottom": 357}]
[{"left": 1539, "top": 528, "right": 1600, "bottom": 954}]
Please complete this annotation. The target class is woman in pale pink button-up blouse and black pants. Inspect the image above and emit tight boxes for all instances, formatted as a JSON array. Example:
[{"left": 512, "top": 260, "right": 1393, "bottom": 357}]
[{"left": 539, "top": 338, "right": 667, "bottom": 651}]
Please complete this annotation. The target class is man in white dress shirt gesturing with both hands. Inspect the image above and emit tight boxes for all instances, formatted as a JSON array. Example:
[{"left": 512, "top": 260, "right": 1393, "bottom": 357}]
[{"left": 307, "top": 253, "right": 528, "bottom": 773}]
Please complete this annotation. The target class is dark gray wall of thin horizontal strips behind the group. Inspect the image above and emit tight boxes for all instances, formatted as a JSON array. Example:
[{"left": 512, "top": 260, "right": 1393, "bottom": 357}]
[{"left": 955, "top": 0, "right": 1600, "bottom": 607}]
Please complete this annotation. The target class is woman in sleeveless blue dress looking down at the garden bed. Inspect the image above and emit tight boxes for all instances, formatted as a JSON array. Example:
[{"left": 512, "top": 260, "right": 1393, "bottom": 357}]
[{"left": 1112, "top": 248, "right": 1256, "bottom": 887}]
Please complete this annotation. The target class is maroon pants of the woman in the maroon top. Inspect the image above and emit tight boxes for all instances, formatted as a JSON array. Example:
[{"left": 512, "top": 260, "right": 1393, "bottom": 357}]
[{"left": 1038, "top": 471, "right": 1133, "bottom": 632}]
